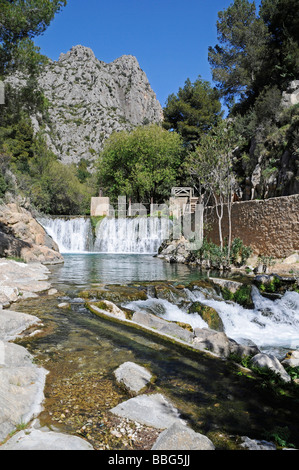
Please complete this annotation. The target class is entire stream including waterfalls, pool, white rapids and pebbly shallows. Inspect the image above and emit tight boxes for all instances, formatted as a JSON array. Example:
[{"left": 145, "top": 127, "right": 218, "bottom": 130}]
[{"left": 14, "top": 218, "right": 299, "bottom": 449}]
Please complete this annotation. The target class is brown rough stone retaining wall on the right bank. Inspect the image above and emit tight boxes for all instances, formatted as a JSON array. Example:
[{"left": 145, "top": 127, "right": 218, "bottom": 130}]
[{"left": 205, "top": 194, "right": 299, "bottom": 258}]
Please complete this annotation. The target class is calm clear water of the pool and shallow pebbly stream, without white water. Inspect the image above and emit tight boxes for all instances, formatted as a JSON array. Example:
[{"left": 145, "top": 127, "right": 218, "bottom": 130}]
[{"left": 16, "top": 253, "right": 299, "bottom": 449}]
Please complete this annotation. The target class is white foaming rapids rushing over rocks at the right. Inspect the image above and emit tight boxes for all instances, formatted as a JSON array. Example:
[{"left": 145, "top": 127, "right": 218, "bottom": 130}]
[{"left": 126, "top": 286, "right": 299, "bottom": 350}]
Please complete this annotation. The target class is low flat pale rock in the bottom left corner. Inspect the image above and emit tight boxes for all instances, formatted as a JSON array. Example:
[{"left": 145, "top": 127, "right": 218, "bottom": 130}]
[{"left": 0, "top": 429, "right": 94, "bottom": 450}]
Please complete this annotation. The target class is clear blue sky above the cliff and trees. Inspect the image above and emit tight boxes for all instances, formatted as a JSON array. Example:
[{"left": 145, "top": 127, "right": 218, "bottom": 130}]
[{"left": 35, "top": 0, "right": 259, "bottom": 106}]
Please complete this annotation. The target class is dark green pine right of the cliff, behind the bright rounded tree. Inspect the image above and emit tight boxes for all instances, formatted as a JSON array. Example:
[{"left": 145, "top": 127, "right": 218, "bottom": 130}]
[{"left": 163, "top": 76, "right": 222, "bottom": 148}]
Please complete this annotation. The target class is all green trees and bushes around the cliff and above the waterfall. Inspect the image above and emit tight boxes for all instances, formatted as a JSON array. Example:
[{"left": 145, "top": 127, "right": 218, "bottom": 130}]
[{"left": 0, "top": 0, "right": 299, "bottom": 225}]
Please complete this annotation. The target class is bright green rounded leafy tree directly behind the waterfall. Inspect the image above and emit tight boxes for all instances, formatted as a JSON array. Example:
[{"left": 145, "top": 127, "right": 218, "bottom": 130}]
[{"left": 98, "top": 124, "right": 183, "bottom": 203}]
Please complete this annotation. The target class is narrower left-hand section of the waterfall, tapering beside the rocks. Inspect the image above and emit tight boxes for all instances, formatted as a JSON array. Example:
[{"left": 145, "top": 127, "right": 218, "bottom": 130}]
[{"left": 38, "top": 217, "right": 93, "bottom": 253}]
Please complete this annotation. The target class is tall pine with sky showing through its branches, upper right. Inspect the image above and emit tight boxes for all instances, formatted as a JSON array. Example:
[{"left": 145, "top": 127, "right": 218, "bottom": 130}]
[{"left": 208, "top": 0, "right": 270, "bottom": 104}]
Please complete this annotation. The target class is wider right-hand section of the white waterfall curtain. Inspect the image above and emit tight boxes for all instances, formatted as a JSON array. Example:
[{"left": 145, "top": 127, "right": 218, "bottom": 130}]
[{"left": 94, "top": 217, "right": 171, "bottom": 254}]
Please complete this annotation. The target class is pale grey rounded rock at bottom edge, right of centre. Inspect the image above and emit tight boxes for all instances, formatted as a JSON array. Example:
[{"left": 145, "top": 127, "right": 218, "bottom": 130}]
[{"left": 151, "top": 422, "right": 215, "bottom": 451}]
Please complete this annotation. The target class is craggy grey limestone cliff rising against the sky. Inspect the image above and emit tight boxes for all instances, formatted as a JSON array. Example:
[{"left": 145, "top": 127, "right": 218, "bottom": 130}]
[{"left": 34, "top": 46, "right": 163, "bottom": 164}]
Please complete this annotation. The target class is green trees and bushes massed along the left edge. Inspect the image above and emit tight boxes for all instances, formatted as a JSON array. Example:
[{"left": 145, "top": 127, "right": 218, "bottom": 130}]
[{"left": 0, "top": 0, "right": 95, "bottom": 215}]
